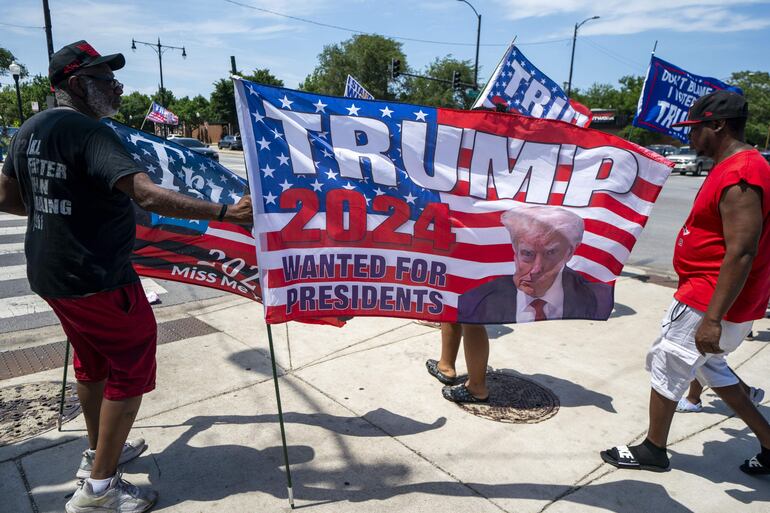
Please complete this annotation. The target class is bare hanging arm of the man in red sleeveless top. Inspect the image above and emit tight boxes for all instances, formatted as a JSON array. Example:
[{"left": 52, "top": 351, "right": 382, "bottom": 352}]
[{"left": 695, "top": 182, "right": 762, "bottom": 354}]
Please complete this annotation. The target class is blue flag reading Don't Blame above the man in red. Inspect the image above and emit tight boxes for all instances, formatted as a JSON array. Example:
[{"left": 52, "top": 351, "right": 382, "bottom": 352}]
[{"left": 633, "top": 56, "right": 743, "bottom": 143}]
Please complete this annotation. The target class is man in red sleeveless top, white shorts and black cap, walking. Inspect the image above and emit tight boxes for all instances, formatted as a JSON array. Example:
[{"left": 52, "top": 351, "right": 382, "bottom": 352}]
[{"left": 601, "top": 91, "right": 770, "bottom": 474}]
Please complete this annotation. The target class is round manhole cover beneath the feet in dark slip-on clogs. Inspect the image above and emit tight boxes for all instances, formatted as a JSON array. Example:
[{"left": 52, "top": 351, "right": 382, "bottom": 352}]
[{"left": 459, "top": 371, "right": 559, "bottom": 424}]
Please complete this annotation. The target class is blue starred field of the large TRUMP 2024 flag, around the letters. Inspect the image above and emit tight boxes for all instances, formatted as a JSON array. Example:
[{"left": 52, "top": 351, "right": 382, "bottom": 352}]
[{"left": 244, "top": 82, "right": 439, "bottom": 219}]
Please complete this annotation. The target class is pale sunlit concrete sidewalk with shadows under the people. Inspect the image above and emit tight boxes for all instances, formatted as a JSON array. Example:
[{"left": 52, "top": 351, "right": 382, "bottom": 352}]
[{"left": 0, "top": 270, "right": 770, "bottom": 513}]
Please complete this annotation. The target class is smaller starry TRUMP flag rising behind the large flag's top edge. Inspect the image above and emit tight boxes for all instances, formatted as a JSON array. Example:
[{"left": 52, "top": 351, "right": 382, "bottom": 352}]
[{"left": 473, "top": 44, "right": 591, "bottom": 127}]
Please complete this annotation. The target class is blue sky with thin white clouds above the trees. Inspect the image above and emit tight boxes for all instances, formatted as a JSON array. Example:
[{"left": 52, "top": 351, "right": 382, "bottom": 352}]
[{"left": 0, "top": 0, "right": 770, "bottom": 103}]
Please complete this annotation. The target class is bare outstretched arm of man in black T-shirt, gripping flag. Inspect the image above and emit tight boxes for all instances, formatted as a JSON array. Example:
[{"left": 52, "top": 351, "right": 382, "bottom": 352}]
[{"left": 115, "top": 173, "right": 253, "bottom": 224}]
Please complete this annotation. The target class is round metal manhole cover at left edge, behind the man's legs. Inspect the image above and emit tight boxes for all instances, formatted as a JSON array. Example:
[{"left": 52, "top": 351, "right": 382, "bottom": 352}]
[{"left": 0, "top": 382, "right": 80, "bottom": 446}]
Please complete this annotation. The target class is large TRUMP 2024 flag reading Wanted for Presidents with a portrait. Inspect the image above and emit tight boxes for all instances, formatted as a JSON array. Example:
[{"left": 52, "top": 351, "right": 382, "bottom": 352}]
[{"left": 235, "top": 79, "right": 670, "bottom": 323}]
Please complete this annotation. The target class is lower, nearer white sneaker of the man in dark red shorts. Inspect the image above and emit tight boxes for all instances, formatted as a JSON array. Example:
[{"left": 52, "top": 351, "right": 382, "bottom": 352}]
[{"left": 64, "top": 473, "right": 158, "bottom": 513}]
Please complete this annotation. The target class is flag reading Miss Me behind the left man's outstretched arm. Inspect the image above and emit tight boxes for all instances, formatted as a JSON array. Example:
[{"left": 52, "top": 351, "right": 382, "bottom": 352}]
[{"left": 103, "top": 120, "right": 261, "bottom": 301}]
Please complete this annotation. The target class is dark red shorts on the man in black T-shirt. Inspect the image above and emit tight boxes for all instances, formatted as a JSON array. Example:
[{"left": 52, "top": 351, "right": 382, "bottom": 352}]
[{"left": 43, "top": 281, "right": 158, "bottom": 401}]
